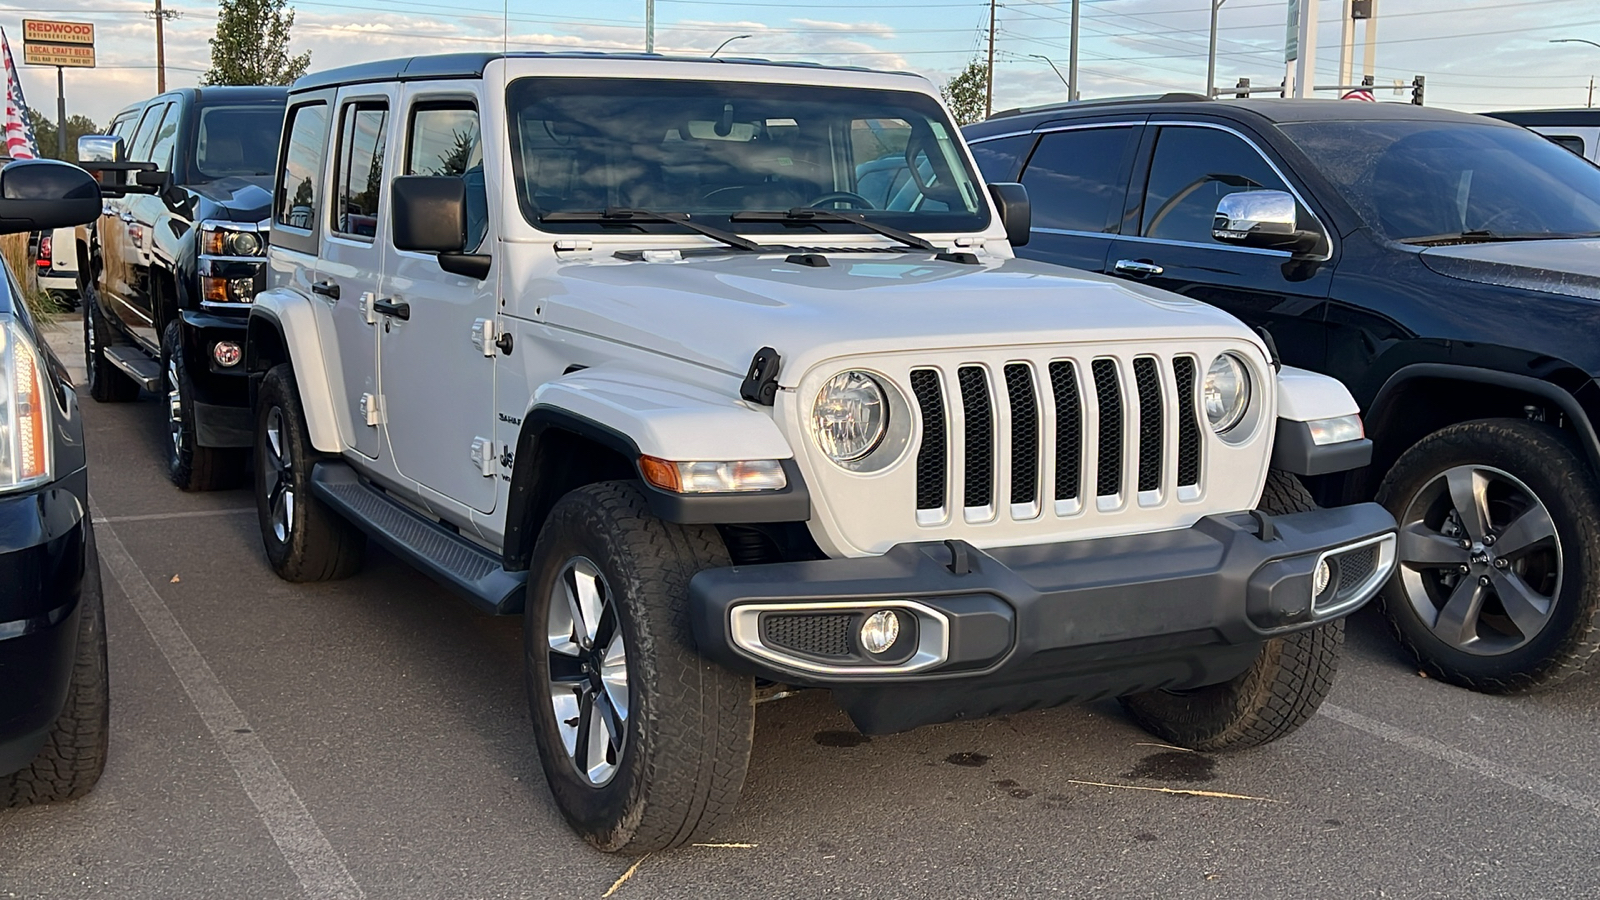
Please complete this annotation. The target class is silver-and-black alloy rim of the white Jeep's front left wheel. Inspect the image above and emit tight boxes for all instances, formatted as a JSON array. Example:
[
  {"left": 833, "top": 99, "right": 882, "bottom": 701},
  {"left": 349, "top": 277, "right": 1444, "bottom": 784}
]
[{"left": 546, "top": 556, "right": 630, "bottom": 788}]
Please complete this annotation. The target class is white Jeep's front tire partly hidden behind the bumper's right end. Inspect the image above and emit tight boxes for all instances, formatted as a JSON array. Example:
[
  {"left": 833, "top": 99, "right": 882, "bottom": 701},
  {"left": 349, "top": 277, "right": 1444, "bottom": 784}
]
[{"left": 1122, "top": 469, "right": 1344, "bottom": 751}]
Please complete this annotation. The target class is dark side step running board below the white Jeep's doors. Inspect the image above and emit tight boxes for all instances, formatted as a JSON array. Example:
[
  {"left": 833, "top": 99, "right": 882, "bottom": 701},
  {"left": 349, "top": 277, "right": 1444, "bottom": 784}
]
[{"left": 310, "top": 461, "right": 528, "bottom": 615}]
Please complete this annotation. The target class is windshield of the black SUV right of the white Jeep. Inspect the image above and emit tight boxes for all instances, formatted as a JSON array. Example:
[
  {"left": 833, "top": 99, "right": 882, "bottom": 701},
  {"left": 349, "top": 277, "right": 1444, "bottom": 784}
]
[{"left": 1282, "top": 120, "right": 1600, "bottom": 243}]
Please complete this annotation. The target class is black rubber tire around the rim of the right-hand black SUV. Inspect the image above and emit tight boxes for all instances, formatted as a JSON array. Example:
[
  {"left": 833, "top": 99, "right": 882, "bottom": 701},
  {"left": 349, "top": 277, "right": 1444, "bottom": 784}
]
[{"left": 1378, "top": 420, "right": 1600, "bottom": 690}]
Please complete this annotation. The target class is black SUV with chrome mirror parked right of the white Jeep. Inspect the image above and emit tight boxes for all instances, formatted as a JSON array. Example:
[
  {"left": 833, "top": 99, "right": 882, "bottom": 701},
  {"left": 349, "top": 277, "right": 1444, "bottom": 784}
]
[{"left": 966, "top": 94, "right": 1600, "bottom": 692}]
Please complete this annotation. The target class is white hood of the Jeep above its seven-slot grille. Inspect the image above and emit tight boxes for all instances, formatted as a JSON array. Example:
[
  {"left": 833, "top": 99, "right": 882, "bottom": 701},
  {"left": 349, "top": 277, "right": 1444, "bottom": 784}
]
[{"left": 536, "top": 253, "right": 1259, "bottom": 377}]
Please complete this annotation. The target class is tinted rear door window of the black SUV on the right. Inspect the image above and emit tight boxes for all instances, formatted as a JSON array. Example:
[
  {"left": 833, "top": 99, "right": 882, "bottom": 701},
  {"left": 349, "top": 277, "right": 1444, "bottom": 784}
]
[{"left": 1022, "top": 127, "right": 1132, "bottom": 237}]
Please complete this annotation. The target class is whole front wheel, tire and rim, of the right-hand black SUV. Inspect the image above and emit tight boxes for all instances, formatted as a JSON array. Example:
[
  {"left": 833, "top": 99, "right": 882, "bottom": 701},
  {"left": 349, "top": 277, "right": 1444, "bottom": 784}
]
[{"left": 1378, "top": 420, "right": 1600, "bottom": 693}]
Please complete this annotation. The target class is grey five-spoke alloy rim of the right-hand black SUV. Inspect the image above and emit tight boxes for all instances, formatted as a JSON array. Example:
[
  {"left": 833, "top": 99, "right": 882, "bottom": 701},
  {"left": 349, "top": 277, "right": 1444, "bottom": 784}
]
[{"left": 1398, "top": 466, "right": 1563, "bottom": 657}]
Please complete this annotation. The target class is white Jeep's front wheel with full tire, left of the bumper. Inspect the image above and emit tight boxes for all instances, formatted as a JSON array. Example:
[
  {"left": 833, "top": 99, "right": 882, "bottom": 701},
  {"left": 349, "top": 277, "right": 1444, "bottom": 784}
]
[{"left": 523, "top": 482, "right": 755, "bottom": 854}]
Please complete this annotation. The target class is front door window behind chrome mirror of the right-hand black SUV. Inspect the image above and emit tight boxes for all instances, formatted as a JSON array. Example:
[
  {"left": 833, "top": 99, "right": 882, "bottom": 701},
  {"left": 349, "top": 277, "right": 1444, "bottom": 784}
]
[{"left": 1139, "top": 127, "right": 1288, "bottom": 243}]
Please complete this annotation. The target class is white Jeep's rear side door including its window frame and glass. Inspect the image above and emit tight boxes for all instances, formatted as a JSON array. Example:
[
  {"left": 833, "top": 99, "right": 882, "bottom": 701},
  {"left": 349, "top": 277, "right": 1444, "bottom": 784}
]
[{"left": 315, "top": 85, "right": 398, "bottom": 458}]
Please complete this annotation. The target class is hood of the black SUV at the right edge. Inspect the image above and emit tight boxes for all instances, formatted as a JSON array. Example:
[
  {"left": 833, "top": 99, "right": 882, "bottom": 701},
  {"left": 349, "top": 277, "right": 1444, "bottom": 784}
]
[{"left": 1422, "top": 240, "right": 1600, "bottom": 299}]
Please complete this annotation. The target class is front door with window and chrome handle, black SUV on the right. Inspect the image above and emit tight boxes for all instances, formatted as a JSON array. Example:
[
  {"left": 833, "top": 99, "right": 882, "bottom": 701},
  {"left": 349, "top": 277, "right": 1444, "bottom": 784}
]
[{"left": 1106, "top": 123, "right": 1333, "bottom": 368}]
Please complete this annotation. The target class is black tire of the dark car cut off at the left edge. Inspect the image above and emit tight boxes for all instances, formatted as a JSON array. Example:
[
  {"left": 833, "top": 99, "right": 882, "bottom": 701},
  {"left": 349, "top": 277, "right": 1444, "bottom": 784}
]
[{"left": 0, "top": 519, "right": 110, "bottom": 809}]
